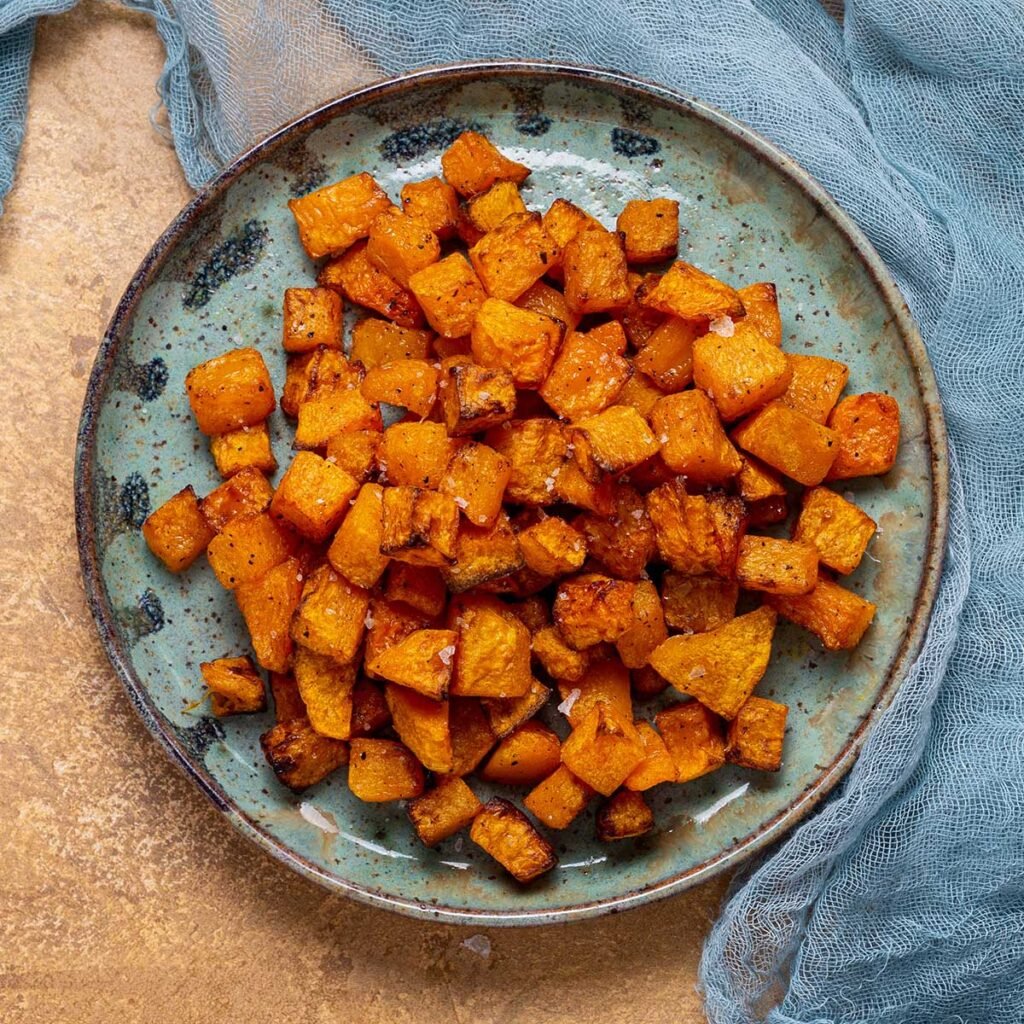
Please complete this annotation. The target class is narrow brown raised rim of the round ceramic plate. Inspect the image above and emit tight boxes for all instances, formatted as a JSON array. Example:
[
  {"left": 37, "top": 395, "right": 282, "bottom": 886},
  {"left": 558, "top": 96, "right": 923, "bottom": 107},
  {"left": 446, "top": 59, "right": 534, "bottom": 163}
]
[{"left": 74, "top": 59, "right": 949, "bottom": 927}]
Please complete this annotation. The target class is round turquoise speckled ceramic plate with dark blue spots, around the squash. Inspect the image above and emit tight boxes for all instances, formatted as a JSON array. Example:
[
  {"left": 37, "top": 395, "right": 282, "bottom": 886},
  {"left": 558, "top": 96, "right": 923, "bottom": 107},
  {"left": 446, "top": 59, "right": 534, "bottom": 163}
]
[{"left": 76, "top": 62, "right": 946, "bottom": 925}]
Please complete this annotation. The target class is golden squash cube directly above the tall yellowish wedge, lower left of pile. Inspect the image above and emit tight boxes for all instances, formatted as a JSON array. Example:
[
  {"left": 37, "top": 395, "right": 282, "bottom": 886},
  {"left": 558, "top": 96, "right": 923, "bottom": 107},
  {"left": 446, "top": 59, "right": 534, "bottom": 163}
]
[{"left": 292, "top": 565, "right": 370, "bottom": 665}]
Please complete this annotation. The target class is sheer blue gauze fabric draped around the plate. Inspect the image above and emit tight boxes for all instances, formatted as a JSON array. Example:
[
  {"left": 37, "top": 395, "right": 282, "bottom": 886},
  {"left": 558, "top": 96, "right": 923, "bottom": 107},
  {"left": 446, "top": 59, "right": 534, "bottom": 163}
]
[{"left": 0, "top": 0, "right": 1024, "bottom": 1024}]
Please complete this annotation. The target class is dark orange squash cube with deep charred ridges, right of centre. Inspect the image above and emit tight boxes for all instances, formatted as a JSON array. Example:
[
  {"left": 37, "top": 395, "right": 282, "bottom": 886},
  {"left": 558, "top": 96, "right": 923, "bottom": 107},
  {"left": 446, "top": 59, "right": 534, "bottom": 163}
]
[{"left": 647, "top": 480, "right": 746, "bottom": 580}]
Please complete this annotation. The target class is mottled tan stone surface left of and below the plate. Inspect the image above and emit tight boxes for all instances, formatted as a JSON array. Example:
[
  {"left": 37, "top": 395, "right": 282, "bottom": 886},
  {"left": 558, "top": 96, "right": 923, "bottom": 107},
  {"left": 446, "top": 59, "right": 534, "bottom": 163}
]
[{"left": 0, "top": 5, "right": 723, "bottom": 1024}]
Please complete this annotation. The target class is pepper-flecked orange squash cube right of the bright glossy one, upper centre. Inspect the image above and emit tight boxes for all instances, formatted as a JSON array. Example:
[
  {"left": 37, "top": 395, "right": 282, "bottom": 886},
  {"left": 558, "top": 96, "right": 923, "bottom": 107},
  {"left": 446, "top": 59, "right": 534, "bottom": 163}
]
[{"left": 540, "top": 321, "right": 633, "bottom": 420}]
